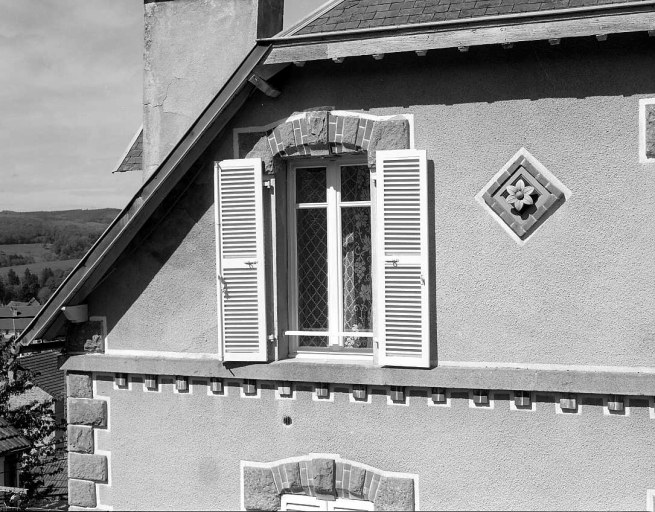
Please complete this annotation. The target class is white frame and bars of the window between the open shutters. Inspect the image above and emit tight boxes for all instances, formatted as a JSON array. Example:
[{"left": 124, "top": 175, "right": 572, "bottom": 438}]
[{"left": 285, "top": 155, "right": 376, "bottom": 361}]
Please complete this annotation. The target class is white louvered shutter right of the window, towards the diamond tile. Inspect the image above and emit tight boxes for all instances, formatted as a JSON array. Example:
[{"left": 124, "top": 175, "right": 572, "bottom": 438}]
[{"left": 376, "top": 150, "right": 430, "bottom": 368}]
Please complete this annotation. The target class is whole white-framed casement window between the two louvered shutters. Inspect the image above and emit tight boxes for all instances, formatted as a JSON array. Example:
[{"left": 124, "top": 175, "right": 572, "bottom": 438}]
[{"left": 287, "top": 160, "right": 373, "bottom": 354}]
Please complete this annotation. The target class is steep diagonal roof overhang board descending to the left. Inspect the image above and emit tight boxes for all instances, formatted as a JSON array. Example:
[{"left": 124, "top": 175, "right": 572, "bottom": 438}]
[{"left": 18, "top": 45, "right": 270, "bottom": 345}]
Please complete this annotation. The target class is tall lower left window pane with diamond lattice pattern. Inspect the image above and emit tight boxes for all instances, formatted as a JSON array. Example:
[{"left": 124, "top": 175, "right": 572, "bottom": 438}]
[{"left": 296, "top": 208, "right": 328, "bottom": 331}]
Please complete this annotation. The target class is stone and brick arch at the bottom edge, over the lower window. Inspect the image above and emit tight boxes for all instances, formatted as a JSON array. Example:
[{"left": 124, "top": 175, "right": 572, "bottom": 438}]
[{"left": 241, "top": 455, "right": 417, "bottom": 510}]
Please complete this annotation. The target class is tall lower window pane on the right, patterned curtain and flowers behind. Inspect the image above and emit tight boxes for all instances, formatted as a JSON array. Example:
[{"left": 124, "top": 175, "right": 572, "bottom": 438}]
[{"left": 341, "top": 207, "right": 373, "bottom": 342}]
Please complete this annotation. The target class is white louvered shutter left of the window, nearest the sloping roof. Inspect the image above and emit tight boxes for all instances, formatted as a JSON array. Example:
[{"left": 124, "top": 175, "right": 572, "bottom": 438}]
[{"left": 215, "top": 158, "right": 266, "bottom": 361}]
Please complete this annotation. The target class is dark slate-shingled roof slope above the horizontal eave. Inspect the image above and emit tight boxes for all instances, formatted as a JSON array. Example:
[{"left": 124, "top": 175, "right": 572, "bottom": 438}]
[{"left": 285, "top": 0, "right": 646, "bottom": 35}]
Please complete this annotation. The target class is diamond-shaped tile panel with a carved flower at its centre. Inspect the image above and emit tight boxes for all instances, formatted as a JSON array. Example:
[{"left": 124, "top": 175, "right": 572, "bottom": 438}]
[{"left": 476, "top": 148, "right": 571, "bottom": 242}]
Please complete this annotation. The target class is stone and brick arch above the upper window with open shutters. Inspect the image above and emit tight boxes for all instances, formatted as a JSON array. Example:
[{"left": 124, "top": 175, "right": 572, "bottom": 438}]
[{"left": 236, "top": 110, "right": 409, "bottom": 173}]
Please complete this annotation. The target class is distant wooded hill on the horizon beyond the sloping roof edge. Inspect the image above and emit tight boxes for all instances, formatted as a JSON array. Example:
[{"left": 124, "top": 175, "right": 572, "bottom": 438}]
[{"left": 0, "top": 208, "right": 119, "bottom": 259}]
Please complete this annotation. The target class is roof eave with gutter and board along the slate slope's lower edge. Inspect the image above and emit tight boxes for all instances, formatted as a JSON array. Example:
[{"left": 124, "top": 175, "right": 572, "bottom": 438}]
[{"left": 259, "top": 0, "right": 655, "bottom": 64}]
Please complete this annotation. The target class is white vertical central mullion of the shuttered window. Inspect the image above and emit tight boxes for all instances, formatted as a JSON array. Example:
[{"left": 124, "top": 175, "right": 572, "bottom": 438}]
[{"left": 327, "top": 162, "right": 340, "bottom": 345}]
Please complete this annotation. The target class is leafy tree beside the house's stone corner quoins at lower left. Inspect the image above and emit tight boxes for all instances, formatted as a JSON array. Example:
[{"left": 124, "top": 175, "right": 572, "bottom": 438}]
[{"left": 0, "top": 336, "right": 62, "bottom": 508}]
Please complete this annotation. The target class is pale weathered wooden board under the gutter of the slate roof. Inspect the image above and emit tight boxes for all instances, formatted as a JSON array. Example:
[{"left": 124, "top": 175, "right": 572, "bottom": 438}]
[{"left": 265, "top": 9, "right": 655, "bottom": 64}]
